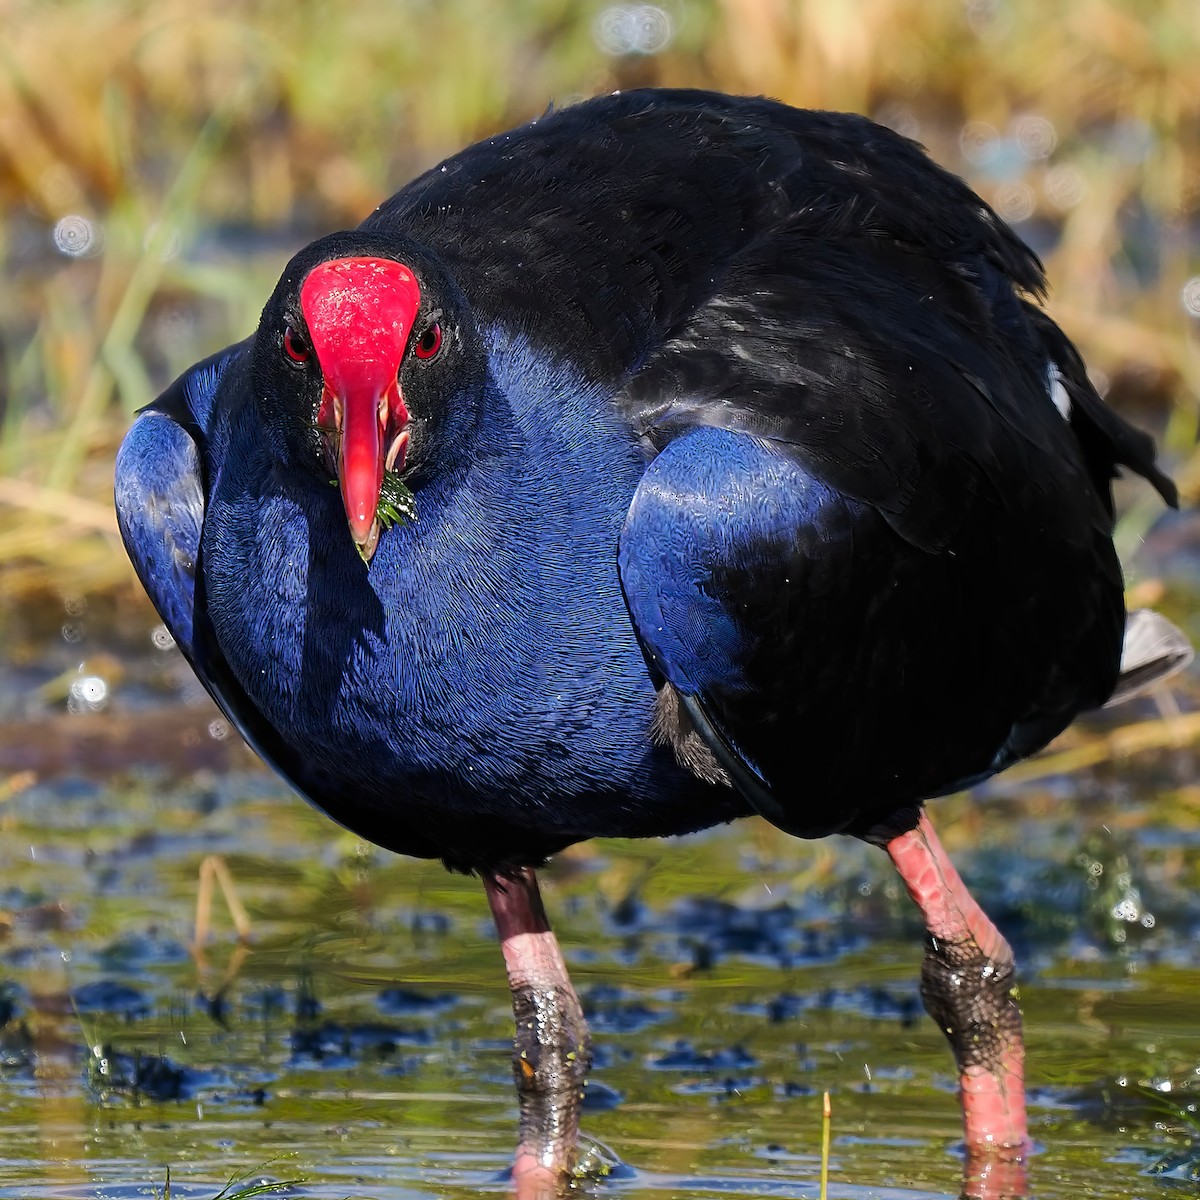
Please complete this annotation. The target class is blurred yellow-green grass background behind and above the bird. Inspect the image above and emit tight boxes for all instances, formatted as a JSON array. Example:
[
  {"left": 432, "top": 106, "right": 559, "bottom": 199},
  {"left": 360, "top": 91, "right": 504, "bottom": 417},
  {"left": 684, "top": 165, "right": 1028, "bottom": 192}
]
[{"left": 0, "top": 0, "right": 1200, "bottom": 600}]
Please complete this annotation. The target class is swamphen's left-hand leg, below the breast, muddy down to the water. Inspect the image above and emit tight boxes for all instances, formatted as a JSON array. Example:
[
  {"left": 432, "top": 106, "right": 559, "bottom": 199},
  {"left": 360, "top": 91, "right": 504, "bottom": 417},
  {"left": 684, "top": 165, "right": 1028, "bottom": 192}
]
[{"left": 484, "top": 868, "right": 592, "bottom": 1195}]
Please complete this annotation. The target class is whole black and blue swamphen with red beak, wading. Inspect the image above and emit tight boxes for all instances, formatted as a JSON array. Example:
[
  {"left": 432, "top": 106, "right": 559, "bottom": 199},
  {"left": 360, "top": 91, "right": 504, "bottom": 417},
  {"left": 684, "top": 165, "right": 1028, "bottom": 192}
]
[{"left": 116, "top": 90, "right": 1187, "bottom": 1185}]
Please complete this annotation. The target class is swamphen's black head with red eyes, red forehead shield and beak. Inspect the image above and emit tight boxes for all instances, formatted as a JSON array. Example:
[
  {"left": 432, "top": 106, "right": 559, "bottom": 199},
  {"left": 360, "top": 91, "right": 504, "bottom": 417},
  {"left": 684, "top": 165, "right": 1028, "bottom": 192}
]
[{"left": 254, "top": 233, "right": 466, "bottom": 560}]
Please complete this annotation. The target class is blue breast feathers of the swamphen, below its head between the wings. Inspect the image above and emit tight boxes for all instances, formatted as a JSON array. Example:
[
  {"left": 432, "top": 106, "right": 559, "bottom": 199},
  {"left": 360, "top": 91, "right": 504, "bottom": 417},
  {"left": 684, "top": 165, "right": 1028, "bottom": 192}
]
[{"left": 194, "top": 324, "right": 734, "bottom": 836}]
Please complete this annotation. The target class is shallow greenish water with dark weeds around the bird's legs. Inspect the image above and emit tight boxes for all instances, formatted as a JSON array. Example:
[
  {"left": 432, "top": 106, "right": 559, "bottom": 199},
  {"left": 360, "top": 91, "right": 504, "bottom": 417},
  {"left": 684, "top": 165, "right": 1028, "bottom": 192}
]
[{"left": 0, "top": 601, "right": 1200, "bottom": 1200}]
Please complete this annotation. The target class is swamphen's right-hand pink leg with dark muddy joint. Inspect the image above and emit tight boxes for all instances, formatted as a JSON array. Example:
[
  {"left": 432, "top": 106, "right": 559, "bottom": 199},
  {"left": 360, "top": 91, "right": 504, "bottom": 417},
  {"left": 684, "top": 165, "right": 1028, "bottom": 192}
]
[{"left": 887, "top": 812, "right": 1028, "bottom": 1158}]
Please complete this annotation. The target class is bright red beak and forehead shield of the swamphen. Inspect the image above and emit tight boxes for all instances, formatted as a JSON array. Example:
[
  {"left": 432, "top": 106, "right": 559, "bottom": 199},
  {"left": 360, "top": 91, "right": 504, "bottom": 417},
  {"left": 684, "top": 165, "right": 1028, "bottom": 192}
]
[{"left": 300, "top": 258, "right": 421, "bottom": 559}]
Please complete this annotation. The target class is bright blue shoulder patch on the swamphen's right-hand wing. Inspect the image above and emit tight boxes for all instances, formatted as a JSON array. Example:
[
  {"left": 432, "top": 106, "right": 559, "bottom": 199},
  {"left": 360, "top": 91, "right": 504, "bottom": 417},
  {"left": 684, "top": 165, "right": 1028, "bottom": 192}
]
[{"left": 619, "top": 426, "right": 850, "bottom": 824}]
